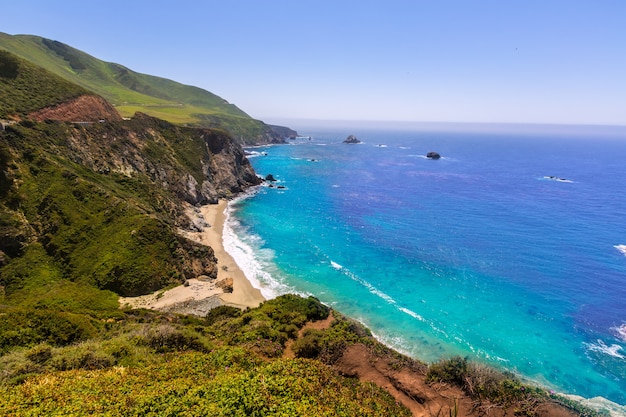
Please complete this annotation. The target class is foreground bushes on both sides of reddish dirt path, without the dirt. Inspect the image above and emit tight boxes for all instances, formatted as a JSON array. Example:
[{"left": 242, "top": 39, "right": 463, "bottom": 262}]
[{"left": 0, "top": 295, "right": 600, "bottom": 416}]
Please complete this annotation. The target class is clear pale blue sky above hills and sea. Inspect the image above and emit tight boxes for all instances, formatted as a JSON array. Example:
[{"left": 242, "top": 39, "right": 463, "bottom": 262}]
[{"left": 0, "top": 0, "right": 626, "bottom": 125}]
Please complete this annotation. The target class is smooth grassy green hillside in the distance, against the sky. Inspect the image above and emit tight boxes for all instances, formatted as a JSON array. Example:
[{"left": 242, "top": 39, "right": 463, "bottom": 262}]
[{"left": 0, "top": 32, "right": 282, "bottom": 143}]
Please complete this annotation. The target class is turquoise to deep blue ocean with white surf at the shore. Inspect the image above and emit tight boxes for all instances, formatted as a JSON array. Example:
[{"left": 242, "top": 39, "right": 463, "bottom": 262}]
[{"left": 225, "top": 125, "right": 626, "bottom": 410}]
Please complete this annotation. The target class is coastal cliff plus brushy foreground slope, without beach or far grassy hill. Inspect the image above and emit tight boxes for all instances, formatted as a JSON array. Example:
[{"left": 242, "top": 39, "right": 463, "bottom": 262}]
[{"left": 0, "top": 45, "right": 591, "bottom": 416}]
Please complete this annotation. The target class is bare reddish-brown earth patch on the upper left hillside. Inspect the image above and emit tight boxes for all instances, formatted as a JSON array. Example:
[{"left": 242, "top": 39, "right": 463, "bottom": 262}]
[{"left": 28, "top": 95, "right": 122, "bottom": 123}]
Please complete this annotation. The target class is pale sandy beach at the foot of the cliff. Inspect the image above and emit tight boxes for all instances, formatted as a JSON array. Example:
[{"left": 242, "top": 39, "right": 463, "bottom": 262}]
[{"left": 120, "top": 200, "right": 265, "bottom": 316}]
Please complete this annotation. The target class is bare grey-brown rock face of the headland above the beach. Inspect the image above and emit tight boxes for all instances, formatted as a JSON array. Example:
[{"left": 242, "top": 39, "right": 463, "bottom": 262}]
[{"left": 59, "top": 113, "right": 261, "bottom": 204}]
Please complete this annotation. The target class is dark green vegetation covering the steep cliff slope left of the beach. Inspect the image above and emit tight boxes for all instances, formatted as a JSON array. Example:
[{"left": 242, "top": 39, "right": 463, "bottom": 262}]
[{"left": 0, "top": 123, "right": 222, "bottom": 295}]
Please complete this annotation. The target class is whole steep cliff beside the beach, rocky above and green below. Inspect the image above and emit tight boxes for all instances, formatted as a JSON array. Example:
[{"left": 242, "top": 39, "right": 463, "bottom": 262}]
[{"left": 0, "top": 110, "right": 261, "bottom": 295}]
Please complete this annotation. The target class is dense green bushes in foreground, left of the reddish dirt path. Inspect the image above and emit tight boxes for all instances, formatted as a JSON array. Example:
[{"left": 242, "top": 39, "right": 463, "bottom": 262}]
[{"left": 0, "top": 295, "right": 410, "bottom": 416}]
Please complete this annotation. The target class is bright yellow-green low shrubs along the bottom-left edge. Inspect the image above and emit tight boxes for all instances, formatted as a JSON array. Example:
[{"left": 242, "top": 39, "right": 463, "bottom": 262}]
[{"left": 0, "top": 348, "right": 410, "bottom": 416}]
